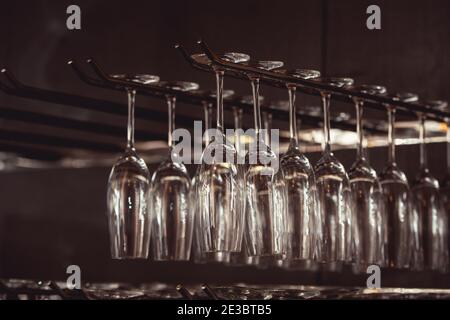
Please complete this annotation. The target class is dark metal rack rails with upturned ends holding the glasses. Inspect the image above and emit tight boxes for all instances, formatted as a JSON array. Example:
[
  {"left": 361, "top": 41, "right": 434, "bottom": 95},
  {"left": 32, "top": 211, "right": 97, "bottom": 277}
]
[{"left": 0, "top": 41, "right": 450, "bottom": 164}]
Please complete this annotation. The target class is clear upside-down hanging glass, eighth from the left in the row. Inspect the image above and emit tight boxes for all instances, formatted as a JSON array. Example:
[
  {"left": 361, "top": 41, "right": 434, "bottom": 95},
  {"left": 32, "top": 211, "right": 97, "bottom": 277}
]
[{"left": 379, "top": 93, "right": 418, "bottom": 268}]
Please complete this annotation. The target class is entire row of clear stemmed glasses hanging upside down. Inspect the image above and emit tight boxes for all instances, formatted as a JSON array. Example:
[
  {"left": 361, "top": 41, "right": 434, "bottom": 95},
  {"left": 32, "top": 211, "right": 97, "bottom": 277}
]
[{"left": 107, "top": 49, "right": 450, "bottom": 272}]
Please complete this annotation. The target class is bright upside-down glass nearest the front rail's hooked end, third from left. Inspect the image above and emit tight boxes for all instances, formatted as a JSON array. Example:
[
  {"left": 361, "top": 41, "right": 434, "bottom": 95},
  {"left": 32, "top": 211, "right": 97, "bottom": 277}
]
[{"left": 197, "top": 53, "right": 249, "bottom": 260}]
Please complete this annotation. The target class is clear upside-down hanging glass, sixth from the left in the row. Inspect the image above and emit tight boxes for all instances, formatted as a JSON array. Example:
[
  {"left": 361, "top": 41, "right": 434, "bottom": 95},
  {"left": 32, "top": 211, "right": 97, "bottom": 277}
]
[{"left": 314, "top": 78, "right": 353, "bottom": 263}]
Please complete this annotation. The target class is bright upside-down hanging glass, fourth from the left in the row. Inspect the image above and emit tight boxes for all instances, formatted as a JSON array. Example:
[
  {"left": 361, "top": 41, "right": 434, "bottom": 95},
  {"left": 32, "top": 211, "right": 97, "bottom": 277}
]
[{"left": 245, "top": 61, "right": 287, "bottom": 262}]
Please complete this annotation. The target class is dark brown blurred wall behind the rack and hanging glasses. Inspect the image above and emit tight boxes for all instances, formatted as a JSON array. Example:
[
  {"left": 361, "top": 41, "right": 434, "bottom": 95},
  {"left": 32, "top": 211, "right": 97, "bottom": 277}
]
[{"left": 0, "top": 0, "right": 450, "bottom": 286}]
